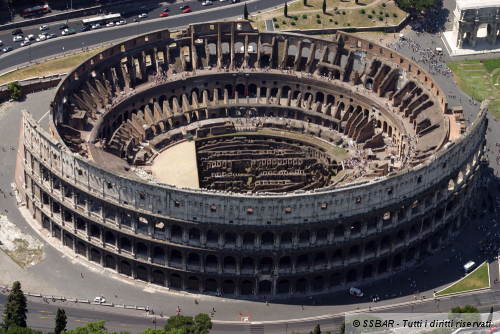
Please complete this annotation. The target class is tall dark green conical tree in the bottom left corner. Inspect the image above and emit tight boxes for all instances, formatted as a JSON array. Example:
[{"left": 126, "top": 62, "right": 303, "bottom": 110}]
[{"left": 2, "top": 281, "right": 28, "bottom": 332}]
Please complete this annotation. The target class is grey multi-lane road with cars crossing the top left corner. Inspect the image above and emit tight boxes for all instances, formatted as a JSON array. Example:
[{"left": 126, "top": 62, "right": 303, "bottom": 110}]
[{"left": 0, "top": 0, "right": 278, "bottom": 72}]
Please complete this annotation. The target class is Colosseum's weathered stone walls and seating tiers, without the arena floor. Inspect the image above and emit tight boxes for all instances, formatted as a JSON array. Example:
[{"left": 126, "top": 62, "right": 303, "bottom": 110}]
[{"left": 15, "top": 22, "right": 488, "bottom": 294}]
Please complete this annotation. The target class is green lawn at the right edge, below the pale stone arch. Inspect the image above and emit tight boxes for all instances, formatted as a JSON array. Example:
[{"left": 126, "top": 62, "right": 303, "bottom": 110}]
[{"left": 446, "top": 59, "right": 500, "bottom": 119}]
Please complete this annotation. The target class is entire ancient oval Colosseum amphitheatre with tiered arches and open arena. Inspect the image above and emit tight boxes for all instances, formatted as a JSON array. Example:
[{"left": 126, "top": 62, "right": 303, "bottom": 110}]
[{"left": 15, "top": 21, "right": 488, "bottom": 296}]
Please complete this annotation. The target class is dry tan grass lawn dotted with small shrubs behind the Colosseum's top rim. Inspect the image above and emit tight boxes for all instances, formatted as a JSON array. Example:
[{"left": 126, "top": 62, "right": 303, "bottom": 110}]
[{"left": 257, "top": 0, "right": 406, "bottom": 30}]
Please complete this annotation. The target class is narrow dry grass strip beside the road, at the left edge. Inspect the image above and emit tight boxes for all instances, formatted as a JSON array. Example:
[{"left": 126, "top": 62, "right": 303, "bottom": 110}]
[{"left": 0, "top": 48, "right": 104, "bottom": 85}]
